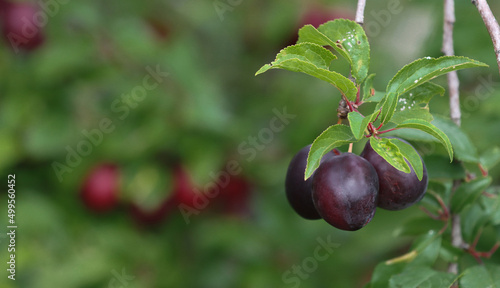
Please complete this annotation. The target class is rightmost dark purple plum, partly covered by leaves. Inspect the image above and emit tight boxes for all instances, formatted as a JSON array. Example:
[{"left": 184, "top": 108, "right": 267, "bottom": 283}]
[{"left": 361, "top": 139, "right": 429, "bottom": 211}]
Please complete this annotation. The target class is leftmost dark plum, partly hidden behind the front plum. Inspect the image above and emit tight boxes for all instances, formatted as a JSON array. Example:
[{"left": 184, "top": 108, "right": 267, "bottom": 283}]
[{"left": 285, "top": 145, "right": 340, "bottom": 220}]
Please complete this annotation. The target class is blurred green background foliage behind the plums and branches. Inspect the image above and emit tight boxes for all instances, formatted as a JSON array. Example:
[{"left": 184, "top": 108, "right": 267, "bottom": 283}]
[{"left": 0, "top": 0, "right": 500, "bottom": 288}]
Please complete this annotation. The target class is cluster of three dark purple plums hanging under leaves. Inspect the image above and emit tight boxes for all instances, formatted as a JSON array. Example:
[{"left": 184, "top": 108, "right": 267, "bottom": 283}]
[{"left": 285, "top": 139, "right": 428, "bottom": 231}]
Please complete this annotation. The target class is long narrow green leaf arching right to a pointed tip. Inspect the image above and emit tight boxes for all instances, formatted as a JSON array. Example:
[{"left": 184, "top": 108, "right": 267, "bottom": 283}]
[{"left": 380, "top": 56, "right": 487, "bottom": 123}]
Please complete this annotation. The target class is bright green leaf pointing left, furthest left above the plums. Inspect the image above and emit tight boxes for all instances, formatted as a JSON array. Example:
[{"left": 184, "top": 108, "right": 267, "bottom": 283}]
[{"left": 255, "top": 43, "right": 358, "bottom": 101}]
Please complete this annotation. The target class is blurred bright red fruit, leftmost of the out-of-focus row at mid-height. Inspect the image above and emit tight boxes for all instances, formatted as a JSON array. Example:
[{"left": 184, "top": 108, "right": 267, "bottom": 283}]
[{"left": 81, "top": 164, "right": 120, "bottom": 212}]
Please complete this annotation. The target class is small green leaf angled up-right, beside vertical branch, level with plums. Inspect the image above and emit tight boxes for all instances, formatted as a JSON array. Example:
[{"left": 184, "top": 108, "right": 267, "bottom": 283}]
[{"left": 451, "top": 177, "right": 491, "bottom": 213}]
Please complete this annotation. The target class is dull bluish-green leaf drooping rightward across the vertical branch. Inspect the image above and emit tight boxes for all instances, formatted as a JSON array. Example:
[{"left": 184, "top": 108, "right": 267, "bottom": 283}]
[{"left": 432, "top": 115, "right": 479, "bottom": 163}]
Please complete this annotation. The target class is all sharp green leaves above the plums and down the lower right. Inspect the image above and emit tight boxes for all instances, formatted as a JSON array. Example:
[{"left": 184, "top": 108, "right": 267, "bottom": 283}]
[{"left": 256, "top": 19, "right": 500, "bottom": 287}]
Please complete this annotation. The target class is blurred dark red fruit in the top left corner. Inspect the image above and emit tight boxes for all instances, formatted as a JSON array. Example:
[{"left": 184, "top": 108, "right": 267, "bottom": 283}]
[{"left": 1, "top": 2, "right": 44, "bottom": 53}]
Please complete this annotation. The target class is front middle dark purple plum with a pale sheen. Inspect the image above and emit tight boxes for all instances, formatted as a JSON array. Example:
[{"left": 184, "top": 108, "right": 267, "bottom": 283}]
[{"left": 312, "top": 153, "right": 378, "bottom": 231}]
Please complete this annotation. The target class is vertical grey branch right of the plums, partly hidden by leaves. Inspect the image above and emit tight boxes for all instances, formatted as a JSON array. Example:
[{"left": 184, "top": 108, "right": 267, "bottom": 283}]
[{"left": 442, "top": 0, "right": 464, "bottom": 280}]
